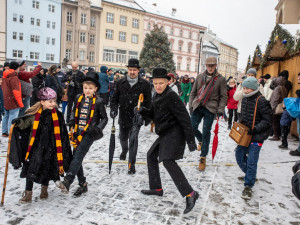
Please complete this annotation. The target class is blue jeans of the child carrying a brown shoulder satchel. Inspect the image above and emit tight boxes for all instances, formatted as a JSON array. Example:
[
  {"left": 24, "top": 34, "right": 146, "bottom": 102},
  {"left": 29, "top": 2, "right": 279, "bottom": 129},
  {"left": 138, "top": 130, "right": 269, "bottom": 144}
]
[{"left": 235, "top": 143, "right": 261, "bottom": 188}]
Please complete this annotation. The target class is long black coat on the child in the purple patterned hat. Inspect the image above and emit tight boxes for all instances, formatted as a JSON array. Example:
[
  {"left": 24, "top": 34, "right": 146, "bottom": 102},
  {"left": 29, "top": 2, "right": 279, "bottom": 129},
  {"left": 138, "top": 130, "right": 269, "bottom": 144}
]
[{"left": 10, "top": 110, "right": 72, "bottom": 183}]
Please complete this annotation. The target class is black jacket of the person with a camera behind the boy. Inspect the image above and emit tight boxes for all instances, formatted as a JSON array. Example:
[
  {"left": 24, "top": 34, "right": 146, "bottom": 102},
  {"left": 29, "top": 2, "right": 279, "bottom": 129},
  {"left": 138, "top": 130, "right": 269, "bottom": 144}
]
[{"left": 61, "top": 70, "right": 84, "bottom": 97}]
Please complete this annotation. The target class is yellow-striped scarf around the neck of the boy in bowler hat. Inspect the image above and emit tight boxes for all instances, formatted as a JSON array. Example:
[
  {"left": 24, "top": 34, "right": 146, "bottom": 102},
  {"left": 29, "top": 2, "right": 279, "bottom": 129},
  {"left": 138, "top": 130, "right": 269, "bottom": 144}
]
[{"left": 71, "top": 94, "right": 96, "bottom": 149}]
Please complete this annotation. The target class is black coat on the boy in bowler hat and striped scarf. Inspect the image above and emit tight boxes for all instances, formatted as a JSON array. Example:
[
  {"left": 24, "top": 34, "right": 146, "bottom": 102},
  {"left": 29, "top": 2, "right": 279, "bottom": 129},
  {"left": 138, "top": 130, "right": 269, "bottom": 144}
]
[{"left": 70, "top": 94, "right": 108, "bottom": 141}]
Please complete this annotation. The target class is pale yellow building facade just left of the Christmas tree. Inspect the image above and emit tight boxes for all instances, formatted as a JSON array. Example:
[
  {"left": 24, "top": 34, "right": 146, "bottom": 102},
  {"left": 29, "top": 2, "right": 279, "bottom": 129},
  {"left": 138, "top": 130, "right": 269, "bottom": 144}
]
[{"left": 99, "top": 0, "right": 145, "bottom": 69}]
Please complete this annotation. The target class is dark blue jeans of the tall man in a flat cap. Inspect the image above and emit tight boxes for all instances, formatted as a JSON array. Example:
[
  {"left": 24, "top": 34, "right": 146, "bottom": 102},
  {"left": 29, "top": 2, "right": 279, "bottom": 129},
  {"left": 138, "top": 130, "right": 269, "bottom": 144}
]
[{"left": 191, "top": 106, "right": 215, "bottom": 157}]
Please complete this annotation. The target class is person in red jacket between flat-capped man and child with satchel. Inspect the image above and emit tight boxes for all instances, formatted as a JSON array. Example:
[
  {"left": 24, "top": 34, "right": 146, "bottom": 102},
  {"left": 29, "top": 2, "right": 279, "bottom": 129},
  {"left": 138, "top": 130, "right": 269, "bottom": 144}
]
[{"left": 227, "top": 79, "right": 239, "bottom": 130}]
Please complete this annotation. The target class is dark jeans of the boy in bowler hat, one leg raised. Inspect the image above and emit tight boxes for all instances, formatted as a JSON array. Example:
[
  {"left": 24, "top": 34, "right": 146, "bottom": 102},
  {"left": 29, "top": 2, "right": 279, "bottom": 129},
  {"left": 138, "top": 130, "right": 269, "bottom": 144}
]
[{"left": 65, "top": 134, "right": 93, "bottom": 184}]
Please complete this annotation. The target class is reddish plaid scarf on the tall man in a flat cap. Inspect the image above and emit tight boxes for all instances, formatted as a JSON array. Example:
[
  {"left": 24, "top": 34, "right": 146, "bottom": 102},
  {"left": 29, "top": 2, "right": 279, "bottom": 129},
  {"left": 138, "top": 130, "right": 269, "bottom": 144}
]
[{"left": 196, "top": 70, "right": 219, "bottom": 105}]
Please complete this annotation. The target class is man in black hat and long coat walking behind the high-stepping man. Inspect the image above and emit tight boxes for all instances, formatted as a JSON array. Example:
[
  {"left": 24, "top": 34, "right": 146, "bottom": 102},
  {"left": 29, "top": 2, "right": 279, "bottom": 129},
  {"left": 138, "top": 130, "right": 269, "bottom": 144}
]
[{"left": 110, "top": 59, "right": 151, "bottom": 174}]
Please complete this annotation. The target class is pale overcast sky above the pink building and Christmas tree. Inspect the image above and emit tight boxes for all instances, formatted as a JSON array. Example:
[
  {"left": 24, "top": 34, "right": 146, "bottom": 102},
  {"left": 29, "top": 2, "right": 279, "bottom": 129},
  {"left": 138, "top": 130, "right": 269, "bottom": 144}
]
[{"left": 147, "top": 0, "right": 278, "bottom": 70}]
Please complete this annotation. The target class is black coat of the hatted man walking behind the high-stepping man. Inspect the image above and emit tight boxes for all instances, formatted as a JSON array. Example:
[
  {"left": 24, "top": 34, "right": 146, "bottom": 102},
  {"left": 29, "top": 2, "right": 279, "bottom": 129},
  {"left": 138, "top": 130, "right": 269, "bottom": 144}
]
[{"left": 110, "top": 76, "right": 151, "bottom": 127}]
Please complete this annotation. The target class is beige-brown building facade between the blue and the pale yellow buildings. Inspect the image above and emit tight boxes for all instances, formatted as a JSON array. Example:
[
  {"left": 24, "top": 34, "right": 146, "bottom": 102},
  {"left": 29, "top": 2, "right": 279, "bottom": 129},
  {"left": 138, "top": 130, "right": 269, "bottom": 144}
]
[{"left": 60, "top": 0, "right": 102, "bottom": 70}]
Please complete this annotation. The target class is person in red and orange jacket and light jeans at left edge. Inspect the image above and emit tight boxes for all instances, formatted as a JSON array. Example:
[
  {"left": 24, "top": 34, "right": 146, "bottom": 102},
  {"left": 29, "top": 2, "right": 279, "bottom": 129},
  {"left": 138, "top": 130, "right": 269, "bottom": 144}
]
[{"left": 2, "top": 62, "right": 24, "bottom": 137}]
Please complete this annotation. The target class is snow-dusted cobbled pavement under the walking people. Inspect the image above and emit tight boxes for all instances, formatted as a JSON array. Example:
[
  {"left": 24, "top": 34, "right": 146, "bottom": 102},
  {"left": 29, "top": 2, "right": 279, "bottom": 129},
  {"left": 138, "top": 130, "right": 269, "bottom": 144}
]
[{"left": 0, "top": 119, "right": 300, "bottom": 225}]
